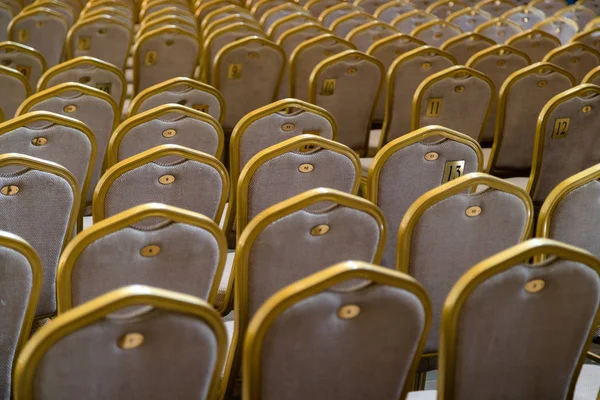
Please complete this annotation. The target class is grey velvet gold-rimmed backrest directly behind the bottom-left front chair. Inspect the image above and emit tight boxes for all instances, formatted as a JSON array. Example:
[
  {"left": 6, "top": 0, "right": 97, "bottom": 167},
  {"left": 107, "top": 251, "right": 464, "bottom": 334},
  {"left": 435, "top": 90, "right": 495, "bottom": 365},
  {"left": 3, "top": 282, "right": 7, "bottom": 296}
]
[{"left": 57, "top": 203, "right": 227, "bottom": 314}]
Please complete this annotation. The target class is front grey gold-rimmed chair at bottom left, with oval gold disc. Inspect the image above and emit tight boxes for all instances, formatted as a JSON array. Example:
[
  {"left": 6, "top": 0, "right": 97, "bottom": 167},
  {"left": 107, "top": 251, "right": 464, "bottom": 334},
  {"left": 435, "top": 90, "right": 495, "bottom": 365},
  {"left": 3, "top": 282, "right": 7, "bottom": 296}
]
[{"left": 14, "top": 285, "right": 227, "bottom": 400}]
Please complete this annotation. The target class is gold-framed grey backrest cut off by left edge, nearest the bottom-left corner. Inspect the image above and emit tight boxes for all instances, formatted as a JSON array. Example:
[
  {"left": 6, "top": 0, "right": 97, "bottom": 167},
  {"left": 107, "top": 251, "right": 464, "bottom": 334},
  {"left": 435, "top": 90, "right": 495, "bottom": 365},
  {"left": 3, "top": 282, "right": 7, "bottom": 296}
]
[{"left": 0, "top": 231, "right": 42, "bottom": 399}]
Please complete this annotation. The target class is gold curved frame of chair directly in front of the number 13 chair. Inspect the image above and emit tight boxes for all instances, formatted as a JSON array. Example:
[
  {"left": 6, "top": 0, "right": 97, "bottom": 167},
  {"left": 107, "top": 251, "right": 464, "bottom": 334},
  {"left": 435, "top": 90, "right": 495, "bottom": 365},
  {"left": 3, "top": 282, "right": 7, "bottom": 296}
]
[{"left": 396, "top": 172, "right": 534, "bottom": 273}]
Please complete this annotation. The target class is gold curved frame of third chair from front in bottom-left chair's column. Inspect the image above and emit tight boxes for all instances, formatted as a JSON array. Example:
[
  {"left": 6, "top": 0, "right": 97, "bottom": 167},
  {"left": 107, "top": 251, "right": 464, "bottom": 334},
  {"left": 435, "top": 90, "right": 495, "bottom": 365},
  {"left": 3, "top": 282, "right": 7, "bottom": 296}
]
[{"left": 92, "top": 144, "right": 229, "bottom": 224}]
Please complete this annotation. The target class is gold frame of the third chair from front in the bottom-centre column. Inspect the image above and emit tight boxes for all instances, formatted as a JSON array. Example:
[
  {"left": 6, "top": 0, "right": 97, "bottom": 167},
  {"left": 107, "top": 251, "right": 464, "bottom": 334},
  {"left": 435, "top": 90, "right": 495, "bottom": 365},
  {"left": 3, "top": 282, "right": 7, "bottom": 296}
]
[{"left": 235, "top": 135, "right": 362, "bottom": 239}]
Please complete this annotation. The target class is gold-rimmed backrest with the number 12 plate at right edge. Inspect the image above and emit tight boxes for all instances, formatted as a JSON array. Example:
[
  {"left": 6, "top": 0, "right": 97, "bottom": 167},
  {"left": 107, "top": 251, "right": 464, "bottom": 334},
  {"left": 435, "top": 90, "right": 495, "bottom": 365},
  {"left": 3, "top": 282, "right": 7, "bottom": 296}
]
[{"left": 527, "top": 84, "right": 600, "bottom": 204}]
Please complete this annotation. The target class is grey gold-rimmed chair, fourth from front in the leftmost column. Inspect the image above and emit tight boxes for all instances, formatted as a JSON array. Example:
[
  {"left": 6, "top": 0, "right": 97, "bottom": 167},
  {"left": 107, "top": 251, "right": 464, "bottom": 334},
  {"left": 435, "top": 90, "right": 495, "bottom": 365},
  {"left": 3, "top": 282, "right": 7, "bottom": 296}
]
[{"left": 17, "top": 83, "right": 119, "bottom": 201}]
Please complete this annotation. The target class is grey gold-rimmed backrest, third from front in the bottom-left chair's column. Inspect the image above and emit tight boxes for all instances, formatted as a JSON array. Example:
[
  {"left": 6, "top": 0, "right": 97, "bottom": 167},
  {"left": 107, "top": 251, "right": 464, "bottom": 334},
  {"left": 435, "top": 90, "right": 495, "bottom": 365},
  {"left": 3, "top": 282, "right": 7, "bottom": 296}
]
[{"left": 92, "top": 144, "right": 229, "bottom": 223}]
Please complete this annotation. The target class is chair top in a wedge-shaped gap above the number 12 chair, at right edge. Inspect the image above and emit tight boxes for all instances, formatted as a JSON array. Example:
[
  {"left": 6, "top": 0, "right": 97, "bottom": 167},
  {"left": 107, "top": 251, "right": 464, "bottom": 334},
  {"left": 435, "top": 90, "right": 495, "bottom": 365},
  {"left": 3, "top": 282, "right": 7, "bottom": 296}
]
[{"left": 543, "top": 43, "right": 600, "bottom": 82}]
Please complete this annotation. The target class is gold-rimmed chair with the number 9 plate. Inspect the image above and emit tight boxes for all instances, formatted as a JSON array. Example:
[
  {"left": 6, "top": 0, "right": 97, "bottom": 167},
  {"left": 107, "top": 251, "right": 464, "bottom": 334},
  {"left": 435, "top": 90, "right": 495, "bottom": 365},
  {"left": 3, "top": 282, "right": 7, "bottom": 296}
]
[{"left": 211, "top": 36, "right": 286, "bottom": 130}]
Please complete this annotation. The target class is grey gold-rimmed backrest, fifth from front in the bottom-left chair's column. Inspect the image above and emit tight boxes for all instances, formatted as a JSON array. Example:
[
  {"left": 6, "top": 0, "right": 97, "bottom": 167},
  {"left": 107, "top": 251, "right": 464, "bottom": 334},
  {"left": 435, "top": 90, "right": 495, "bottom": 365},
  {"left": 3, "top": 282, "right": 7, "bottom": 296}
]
[{"left": 127, "top": 77, "right": 225, "bottom": 122}]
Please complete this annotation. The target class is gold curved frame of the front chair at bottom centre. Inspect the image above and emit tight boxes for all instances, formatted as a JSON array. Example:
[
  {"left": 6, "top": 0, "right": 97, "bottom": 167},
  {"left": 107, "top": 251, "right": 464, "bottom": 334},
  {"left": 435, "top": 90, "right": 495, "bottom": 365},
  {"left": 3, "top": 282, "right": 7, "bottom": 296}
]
[{"left": 243, "top": 261, "right": 432, "bottom": 399}]
